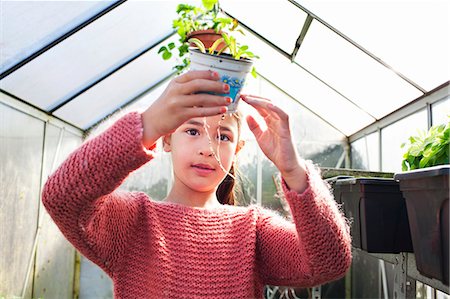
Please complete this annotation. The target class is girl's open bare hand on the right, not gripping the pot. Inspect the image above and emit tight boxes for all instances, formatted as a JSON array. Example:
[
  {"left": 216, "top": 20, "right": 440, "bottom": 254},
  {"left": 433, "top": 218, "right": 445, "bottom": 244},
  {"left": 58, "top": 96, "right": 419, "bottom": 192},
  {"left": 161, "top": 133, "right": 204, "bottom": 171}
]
[{"left": 241, "top": 95, "right": 307, "bottom": 192}]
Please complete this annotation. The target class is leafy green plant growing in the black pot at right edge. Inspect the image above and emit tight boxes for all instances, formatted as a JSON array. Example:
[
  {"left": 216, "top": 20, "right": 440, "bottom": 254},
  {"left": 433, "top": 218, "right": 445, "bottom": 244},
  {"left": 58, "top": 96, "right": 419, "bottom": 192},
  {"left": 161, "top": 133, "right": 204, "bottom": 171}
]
[{"left": 402, "top": 121, "right": 450, "bottom": 171}]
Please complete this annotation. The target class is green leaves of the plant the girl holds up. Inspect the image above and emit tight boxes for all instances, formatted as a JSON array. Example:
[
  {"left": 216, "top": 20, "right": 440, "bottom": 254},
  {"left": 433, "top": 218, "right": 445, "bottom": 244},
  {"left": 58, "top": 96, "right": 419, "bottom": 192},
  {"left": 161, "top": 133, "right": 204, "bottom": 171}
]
[{"left": 158, "top": 0, "right": 257, "bottom": 76}]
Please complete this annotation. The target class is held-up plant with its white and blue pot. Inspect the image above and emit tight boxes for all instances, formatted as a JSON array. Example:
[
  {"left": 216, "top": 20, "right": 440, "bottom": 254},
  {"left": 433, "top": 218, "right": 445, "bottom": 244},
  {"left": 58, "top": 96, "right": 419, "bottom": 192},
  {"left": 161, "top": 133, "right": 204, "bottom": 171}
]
[{"left": 159, "top": 0, "right": 258, "bottom": 112}]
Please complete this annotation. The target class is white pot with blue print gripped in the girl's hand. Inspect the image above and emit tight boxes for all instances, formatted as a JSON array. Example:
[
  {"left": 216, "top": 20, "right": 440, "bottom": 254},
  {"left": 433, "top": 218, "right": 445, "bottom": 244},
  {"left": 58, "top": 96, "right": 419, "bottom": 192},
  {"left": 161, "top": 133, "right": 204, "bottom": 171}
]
[{"left": 189, "top": 48, "right": 253, "bottom": 113}]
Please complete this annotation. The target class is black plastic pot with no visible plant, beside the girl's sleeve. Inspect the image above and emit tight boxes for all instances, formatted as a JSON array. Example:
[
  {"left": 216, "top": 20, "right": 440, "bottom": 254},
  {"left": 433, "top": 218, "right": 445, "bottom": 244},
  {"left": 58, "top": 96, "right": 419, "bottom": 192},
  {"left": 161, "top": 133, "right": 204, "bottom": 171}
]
[{"left": 333, "top": 178, "right": 412, "bottom": 253}]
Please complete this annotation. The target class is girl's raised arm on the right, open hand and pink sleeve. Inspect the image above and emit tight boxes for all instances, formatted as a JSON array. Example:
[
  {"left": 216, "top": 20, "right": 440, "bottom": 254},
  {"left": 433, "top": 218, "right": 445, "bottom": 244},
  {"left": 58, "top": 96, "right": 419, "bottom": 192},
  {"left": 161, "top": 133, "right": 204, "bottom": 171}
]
[{"left": 243, "top": 95, "right": 351, "bottom": 286}]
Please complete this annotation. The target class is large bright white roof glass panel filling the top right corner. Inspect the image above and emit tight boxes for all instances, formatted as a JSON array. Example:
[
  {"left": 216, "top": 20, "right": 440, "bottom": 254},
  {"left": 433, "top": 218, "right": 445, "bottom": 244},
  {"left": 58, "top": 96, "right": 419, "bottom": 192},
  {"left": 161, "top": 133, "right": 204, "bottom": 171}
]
[{"left": 297, "top": 0, "right": 450, "bottom": 91}]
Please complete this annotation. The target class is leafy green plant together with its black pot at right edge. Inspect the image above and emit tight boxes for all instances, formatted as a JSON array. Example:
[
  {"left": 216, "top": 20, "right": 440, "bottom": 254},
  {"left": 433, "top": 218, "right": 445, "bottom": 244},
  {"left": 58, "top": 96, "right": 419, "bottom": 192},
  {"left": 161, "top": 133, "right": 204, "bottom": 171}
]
[{"left": 394, "top": 122, "right": 450, "bottom": 285}]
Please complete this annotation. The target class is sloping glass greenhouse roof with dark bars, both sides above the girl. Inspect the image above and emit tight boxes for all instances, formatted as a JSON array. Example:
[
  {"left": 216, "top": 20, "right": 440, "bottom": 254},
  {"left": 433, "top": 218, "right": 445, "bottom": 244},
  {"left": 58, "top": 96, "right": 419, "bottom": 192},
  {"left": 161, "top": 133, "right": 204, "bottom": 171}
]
[{"left": 0, "top": 0, "right": 450, "bottom": 136}]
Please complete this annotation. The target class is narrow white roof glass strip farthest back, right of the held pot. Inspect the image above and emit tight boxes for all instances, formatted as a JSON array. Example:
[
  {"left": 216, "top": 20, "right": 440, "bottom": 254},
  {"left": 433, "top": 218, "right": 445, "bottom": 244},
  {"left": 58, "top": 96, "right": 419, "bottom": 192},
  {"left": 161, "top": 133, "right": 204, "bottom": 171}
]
[{"left": 237, "top": 28, "right": 374, "bottom": 136}]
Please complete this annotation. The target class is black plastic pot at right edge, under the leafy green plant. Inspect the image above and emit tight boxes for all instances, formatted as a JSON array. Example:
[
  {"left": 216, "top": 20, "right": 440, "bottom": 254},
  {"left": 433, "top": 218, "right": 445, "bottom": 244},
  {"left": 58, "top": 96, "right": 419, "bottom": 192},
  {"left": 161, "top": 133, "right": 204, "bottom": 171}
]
[{"left": 394, "top": 165, "right": 450, "bottom": 285}]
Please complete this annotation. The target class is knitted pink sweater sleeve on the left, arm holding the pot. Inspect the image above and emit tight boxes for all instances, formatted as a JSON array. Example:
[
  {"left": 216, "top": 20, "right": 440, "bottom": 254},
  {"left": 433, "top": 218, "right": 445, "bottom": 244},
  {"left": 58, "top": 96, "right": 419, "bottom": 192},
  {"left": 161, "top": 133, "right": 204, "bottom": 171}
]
[{"left": 42, "top": 112, "right": 153, "bottom": 274}]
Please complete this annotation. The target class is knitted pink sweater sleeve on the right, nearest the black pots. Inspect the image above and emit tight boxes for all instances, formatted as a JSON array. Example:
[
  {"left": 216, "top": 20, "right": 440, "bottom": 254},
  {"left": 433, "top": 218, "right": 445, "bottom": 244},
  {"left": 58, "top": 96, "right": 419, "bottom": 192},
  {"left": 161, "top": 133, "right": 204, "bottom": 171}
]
[{"left": 257, "top": 162, "right": 352, "bottom": 287}]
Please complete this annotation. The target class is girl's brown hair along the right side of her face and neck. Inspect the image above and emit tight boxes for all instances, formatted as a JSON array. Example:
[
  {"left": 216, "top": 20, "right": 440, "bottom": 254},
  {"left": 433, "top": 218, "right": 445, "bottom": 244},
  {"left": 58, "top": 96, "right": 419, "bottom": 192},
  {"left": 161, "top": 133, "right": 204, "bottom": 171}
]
[{"left": 216, "top": 111, "right": 242, "bottom": 206}]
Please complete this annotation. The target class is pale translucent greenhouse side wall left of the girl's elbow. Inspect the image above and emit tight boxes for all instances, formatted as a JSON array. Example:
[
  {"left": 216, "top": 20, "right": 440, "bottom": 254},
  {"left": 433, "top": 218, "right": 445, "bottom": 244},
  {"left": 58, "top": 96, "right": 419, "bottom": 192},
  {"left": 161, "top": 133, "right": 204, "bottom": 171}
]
[{"left": 0, "top": 94, "right": 82, "bottom": 298}]
